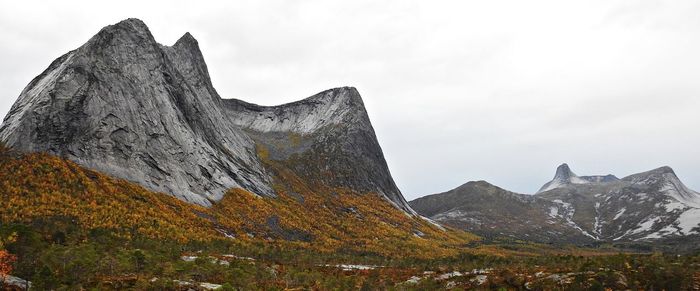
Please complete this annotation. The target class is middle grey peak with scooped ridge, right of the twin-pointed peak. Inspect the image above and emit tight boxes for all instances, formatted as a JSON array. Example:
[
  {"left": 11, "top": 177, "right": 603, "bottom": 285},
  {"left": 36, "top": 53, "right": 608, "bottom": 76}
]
[{"left": 223, "top": 87, "right": 412, "bottom": 213}]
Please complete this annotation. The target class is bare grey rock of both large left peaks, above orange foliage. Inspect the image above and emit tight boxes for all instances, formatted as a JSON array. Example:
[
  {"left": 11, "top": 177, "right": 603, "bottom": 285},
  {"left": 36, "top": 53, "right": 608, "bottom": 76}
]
[{"left": 0, "top": 19, "right": 410, "bottom": 211}]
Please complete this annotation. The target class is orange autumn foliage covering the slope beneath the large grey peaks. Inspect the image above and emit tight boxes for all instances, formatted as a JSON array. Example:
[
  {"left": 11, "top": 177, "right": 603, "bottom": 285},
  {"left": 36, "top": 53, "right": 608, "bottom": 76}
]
[{"left": 0, "top": 145, "right": 475, "bottom": 257}]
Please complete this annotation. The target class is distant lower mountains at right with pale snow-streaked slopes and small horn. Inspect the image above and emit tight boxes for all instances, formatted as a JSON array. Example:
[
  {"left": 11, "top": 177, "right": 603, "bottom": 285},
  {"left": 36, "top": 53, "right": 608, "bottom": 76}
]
[{"left": 410, "top": 164, "right": 700, "bottom": 249}]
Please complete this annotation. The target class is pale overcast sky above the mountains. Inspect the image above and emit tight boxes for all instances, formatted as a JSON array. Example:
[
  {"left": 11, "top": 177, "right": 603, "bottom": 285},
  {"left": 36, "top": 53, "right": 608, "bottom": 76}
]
[{"left": 0, "top": 0, "right": 700, "bottom": 200}]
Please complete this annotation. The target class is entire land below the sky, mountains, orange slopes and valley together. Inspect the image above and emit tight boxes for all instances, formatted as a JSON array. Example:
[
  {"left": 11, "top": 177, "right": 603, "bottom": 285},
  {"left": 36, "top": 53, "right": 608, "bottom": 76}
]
[{"left": 0, "top": 19, "right": 700, "bottom": 290}]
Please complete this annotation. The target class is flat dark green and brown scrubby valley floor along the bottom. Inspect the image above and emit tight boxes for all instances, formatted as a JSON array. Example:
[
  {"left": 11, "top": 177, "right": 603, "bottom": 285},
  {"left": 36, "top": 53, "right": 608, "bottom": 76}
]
[{"left": 0, "top": 224, "right": 700, "bottom": 290}]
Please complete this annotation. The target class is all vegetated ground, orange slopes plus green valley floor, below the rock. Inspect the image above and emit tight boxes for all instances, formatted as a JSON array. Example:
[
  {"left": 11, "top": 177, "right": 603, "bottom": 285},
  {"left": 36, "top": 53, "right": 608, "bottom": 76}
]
[{"left": 0, "top": 149, "right": 700, "bottom": 290}]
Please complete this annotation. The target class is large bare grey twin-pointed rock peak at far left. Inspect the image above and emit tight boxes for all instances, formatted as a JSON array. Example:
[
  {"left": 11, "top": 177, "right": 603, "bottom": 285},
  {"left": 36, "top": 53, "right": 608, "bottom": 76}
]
[{"left": 0, "top": 19, "right": 273, "bottom": 205}]
